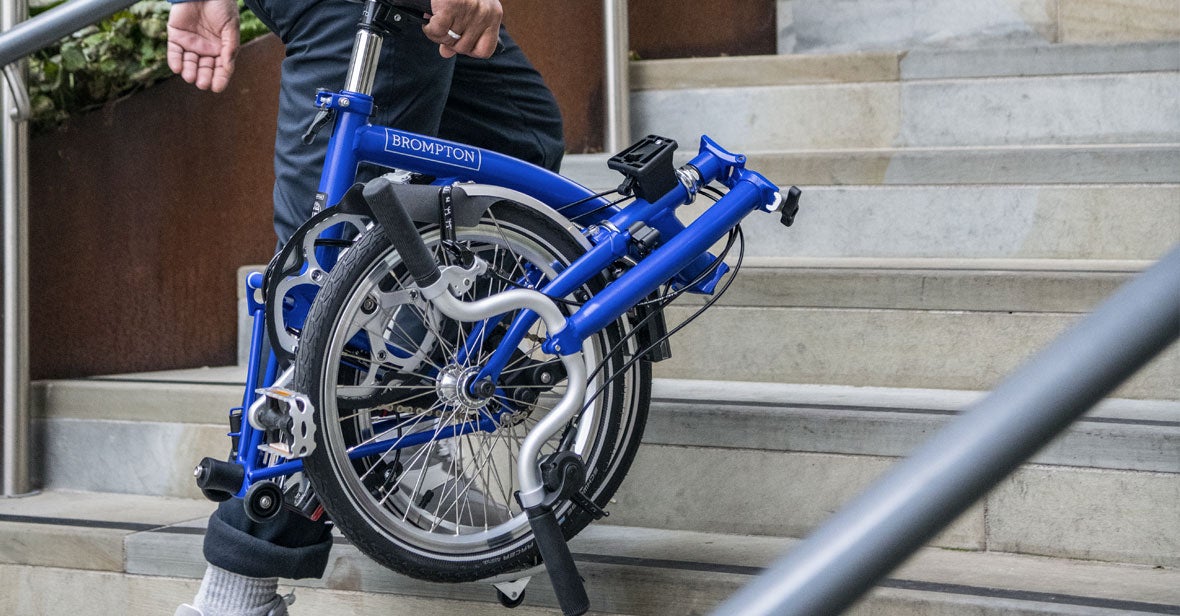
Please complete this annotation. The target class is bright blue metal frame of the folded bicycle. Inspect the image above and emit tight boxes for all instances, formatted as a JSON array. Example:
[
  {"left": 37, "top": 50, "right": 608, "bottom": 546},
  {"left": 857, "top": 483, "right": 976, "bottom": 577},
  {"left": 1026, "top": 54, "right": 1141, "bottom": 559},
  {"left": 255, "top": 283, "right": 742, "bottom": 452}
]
[{"left": 230, "top": 32, "right": 782, "bottom": 497}]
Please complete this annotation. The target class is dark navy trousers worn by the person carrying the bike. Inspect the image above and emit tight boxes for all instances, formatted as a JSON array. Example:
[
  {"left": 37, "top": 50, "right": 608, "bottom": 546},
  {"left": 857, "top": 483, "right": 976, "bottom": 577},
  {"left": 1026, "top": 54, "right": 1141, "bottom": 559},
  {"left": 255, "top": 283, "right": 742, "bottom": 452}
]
[{"left": 204, "top": 0, "right": 564, "bottom": 578}]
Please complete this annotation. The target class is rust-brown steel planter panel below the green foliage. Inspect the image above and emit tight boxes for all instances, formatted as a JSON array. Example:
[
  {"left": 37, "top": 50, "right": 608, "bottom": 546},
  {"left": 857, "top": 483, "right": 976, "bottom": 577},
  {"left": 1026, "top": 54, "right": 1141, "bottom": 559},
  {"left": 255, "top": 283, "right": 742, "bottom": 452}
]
[{"left": 30, "top": 38, "right": 282, "bottom": 379}]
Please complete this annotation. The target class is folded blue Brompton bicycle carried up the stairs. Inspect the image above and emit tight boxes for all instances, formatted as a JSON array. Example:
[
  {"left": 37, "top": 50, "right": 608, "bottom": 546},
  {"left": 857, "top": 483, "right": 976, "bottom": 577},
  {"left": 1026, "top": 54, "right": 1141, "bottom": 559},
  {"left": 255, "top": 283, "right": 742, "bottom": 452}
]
[{"left": 195, "top": 0, "right": 799, "bottom": 614}]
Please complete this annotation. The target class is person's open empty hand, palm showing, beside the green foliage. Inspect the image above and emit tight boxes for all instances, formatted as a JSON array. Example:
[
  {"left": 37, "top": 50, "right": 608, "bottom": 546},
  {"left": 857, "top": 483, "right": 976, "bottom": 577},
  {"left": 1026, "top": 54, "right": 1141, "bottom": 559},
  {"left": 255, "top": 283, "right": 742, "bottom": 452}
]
[{"left": 168, "top": 0, "right": 238, "bottom": 92}]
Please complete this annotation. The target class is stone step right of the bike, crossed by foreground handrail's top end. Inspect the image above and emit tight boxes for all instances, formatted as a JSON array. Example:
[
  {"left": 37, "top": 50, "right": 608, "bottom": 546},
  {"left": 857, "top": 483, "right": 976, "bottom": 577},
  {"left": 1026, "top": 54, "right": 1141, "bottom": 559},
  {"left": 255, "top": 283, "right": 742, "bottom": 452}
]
[{"left": 656, "top": 256, "right": 1180, "bottom": 399}]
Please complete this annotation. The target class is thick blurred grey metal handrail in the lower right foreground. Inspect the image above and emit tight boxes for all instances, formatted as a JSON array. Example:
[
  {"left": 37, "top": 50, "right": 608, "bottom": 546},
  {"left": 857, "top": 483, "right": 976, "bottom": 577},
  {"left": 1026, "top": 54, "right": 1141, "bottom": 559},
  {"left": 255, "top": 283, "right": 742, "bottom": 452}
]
[{"left": 714, "top": 244, "right": 1180, "bottom": 616}]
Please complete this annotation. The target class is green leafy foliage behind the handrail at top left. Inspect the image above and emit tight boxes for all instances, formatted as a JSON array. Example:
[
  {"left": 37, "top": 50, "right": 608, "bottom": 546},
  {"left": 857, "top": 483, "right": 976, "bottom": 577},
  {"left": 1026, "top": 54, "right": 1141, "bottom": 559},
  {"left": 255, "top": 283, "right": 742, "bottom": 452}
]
[{"left": 28, "top": 0, "right": 267, "bottom": 130}]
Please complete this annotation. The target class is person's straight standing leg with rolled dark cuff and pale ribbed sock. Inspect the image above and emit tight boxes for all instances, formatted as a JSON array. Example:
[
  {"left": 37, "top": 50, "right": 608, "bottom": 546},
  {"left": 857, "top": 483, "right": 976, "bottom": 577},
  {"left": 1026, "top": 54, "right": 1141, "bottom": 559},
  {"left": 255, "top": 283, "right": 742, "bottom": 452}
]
[{"left": 178, "top": 0, "right": 453, "bottom": 616}]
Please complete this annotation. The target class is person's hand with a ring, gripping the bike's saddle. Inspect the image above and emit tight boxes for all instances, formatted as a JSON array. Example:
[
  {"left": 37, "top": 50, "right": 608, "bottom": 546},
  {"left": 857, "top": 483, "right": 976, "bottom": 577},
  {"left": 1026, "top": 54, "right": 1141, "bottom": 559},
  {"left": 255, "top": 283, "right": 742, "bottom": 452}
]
[{"left": 422, "top": 0, "right": 504, "bottom": 58}]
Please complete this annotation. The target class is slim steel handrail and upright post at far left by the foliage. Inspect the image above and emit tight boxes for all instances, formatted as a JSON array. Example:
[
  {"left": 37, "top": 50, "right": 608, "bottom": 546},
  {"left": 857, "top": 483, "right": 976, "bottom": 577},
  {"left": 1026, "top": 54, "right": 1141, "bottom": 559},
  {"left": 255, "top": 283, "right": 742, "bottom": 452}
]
[{"left": 0, "top": 0, "right": 135, "bottom": 497}]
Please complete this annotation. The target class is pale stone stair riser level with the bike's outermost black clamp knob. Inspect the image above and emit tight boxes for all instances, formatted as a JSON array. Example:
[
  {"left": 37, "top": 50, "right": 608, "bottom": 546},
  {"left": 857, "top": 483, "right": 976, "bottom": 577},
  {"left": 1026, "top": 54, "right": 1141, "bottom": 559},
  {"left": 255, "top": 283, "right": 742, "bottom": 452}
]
[{"left": 726, "top": 184, "right": 1180, "bottom": 260}]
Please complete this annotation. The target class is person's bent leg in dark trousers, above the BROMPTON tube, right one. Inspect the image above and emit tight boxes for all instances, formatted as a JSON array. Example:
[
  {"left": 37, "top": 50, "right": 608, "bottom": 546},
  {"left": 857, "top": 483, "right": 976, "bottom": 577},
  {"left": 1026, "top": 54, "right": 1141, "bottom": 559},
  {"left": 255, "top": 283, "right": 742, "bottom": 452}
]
[{"left": 439, "top": 27, "right": 565, "bottom": 171}]
